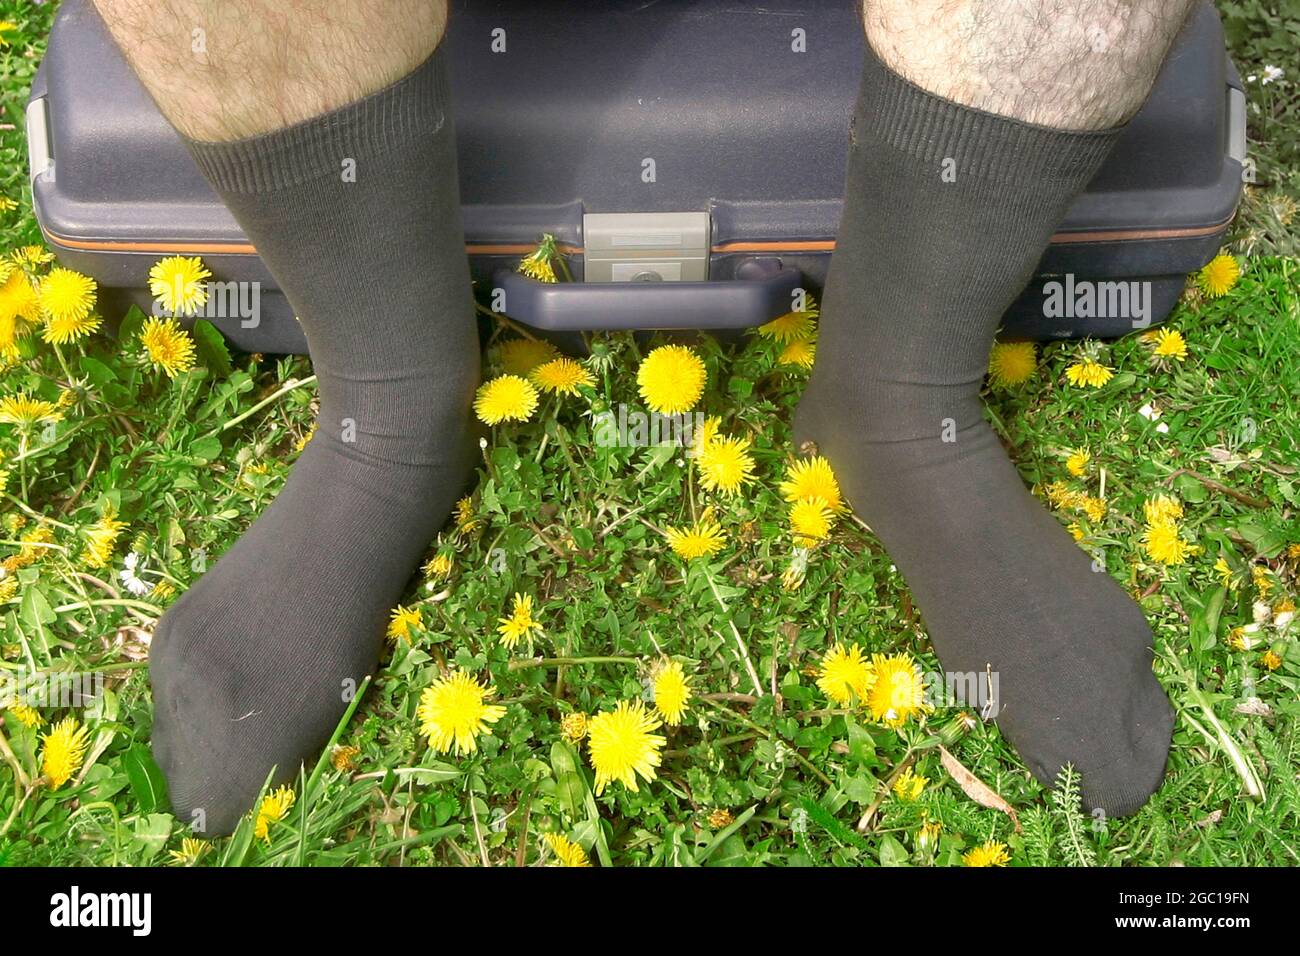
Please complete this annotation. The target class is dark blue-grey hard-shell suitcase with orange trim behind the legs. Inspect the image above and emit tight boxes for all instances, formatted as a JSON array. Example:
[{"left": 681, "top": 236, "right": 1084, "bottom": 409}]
[{"left": 26, "top": 0, "right": 1245, "bottom": 352}]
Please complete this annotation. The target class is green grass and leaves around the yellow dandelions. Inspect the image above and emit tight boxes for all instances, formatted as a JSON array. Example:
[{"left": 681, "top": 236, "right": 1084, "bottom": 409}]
[{"left": 0, "top": 3, "right": 1300, "bottom": 865}]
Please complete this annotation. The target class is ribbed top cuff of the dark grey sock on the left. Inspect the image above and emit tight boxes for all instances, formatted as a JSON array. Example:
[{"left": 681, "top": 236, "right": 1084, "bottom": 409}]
[{"left": 182, "top": 46, "right": 450, "bottom": 193}]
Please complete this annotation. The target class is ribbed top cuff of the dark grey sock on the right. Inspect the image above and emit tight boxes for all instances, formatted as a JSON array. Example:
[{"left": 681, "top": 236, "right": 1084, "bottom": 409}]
[{"left": 854, "top": 43, "right": 1123, "bottom": 193}]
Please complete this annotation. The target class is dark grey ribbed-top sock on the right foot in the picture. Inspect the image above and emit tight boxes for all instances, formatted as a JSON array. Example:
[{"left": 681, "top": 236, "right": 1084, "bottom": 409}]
[{"left": 794, "top": 48, "right": 1173, "bottom": 814}]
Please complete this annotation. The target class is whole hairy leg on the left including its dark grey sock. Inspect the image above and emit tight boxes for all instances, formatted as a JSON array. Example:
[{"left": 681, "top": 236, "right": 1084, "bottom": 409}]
[{"left": 90, "top": 0, "right": 478, "bottom": 835}]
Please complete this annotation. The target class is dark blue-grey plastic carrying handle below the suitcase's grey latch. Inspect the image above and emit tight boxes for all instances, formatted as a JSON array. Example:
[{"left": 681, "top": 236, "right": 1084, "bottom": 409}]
[{"left": 493, "top": 258, "right": 803, "bottom": 332}]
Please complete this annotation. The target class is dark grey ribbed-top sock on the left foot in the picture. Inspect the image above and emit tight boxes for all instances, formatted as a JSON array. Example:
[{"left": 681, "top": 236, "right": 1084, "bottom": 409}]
[{"left": 150, "top": 46, "right": 478, "bottom": 835}]
